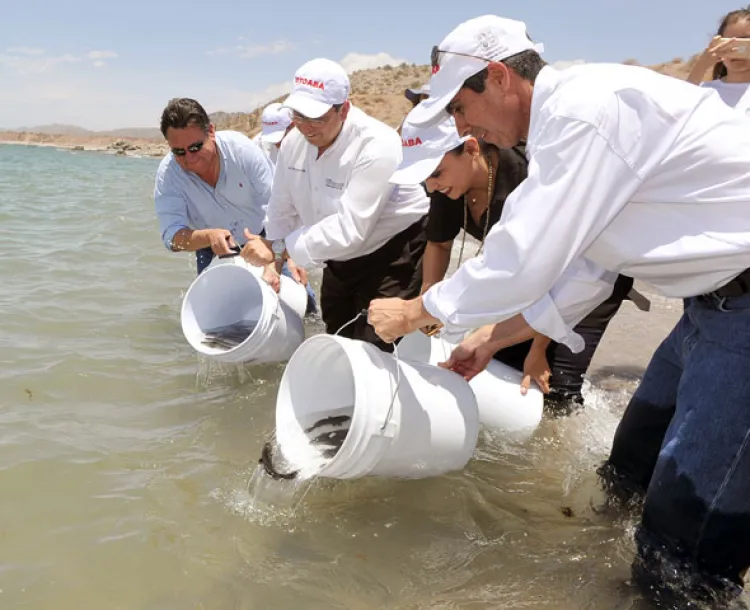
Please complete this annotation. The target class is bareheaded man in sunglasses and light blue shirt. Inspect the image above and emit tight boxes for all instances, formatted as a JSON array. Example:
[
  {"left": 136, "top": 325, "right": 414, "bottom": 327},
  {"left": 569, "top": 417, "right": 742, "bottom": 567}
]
[{"left": 154, "top": 98, "right": 280, "bottom": 273}]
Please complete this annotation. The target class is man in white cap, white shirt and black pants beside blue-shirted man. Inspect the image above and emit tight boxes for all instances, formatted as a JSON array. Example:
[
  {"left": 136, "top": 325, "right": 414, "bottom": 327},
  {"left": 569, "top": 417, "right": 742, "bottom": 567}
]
[{"left": 243, "top": 59, "right": 429, "bottom": 351}]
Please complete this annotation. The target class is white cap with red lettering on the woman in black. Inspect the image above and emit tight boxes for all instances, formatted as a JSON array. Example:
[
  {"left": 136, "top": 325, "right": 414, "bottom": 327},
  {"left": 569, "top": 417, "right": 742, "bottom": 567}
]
[{"left": 389, "top": 110, "right": 469, "bottom": 184}]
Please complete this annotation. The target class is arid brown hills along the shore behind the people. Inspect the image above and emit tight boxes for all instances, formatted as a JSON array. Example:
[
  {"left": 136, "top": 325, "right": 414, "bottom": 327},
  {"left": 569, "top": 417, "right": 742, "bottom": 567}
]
[{"left": 0, "top": 56, "right": 708, "bottom": 156}]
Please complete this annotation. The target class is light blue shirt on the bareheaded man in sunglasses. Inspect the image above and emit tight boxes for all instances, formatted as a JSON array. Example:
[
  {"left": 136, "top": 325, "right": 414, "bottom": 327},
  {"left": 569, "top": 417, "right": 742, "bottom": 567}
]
[{"left": 154, "top": 131, "right": 274, "bottom": 250}]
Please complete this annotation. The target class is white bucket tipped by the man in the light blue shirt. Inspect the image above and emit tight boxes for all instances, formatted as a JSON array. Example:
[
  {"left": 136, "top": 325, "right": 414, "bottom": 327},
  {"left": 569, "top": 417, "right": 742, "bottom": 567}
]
[{"left": 180, "top": 256, "right": 307, "bottom": 363}]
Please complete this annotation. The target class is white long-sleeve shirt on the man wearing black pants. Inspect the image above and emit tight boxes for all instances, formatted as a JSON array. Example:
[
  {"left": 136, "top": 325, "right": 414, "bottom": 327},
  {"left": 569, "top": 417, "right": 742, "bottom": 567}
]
[{"left": 265, "top": 106, "right": 430, "bottom": 267}]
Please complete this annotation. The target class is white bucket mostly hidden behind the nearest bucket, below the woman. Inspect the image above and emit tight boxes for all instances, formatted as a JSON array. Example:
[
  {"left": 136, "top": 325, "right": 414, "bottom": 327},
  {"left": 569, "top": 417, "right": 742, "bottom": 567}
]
[{"left": 398, "top": 331, "right": 544, "bottom": 440}]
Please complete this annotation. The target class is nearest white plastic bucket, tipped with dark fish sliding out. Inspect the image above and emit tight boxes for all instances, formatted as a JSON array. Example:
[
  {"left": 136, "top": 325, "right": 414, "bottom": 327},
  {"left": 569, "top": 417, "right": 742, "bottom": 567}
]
[{"left": 276, "top": 335, "right": 479, "bottom": 479}]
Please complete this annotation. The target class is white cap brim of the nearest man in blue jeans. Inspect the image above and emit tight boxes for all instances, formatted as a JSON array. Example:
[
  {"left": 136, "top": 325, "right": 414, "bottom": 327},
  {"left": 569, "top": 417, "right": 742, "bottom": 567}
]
[{"left": 409, "top": 56, "right": 488, "bottom": 127}]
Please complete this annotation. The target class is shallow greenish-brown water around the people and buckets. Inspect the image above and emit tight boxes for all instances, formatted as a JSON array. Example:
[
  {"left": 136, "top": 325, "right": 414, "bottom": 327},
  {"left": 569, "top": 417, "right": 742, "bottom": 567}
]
[{"left": 0, "top": 146, "right": 740, "bottom": 610}]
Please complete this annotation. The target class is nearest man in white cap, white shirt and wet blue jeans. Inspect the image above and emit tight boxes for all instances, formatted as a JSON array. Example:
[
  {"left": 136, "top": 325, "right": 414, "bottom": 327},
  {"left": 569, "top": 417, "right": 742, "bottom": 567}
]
[{"left": 369, "top": 15, "right": 750, "bottom": 608}]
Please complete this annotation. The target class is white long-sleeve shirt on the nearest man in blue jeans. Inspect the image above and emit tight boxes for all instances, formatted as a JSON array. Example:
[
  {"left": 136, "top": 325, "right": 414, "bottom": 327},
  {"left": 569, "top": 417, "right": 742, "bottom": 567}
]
[{"left": 424, "top": 64, "right": 750, "bottom": 351}]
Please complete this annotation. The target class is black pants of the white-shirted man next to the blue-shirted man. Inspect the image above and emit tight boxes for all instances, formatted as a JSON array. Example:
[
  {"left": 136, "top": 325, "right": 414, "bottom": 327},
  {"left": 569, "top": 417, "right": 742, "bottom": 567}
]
[{"left": 320, "top": 217, "right": 427, "bottom": 353}]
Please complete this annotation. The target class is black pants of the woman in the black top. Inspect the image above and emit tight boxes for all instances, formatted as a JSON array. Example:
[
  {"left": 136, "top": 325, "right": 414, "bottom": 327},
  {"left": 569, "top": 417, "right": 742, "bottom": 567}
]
[{"left": 494, "top": 275, "right": 633, "bottom": 411}]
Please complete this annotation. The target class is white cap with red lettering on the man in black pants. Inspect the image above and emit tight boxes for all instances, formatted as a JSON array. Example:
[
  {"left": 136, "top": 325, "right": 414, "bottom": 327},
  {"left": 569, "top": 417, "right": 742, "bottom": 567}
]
[{"left": 283, "top": 58, "right": 351, "bottom": 119}]
